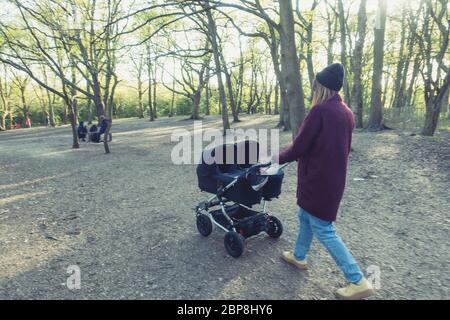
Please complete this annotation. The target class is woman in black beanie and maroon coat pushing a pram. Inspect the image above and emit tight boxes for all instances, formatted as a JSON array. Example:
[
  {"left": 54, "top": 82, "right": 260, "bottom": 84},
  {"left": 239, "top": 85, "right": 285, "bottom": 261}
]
[{"left": 279, "top": 63, "right": 374, "bottom": 299}]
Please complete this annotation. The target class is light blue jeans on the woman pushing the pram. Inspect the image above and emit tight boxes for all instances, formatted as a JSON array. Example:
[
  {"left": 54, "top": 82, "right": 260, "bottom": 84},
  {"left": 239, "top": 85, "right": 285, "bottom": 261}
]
[{"left": 294, "top": 208, "right": 363, "bottom": 283}]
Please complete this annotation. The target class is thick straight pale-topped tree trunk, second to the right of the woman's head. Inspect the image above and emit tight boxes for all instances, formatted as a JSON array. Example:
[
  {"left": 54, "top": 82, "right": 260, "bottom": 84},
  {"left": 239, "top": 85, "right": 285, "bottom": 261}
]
[{"left": 367, "top": 0, "right": 386, "bottom": 131}]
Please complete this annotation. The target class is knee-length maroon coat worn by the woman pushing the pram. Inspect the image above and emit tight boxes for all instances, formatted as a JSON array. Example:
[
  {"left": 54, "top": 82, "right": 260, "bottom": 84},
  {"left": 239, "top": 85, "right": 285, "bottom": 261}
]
[{"left": 279, "top": 94, "right": 355, "bottom": 221}]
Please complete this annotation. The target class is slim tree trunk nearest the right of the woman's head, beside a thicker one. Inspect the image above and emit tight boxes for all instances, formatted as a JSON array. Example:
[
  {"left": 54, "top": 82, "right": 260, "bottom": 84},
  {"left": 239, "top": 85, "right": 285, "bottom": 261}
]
[{"left": 351, "top": 0, "right": 367, "bottom": 128}]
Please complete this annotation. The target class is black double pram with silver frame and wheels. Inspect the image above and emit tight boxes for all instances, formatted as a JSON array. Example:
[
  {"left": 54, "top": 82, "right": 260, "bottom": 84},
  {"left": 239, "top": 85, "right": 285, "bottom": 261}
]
[{"left": 195, "top": 140, "right": 284, "bottom": 257}]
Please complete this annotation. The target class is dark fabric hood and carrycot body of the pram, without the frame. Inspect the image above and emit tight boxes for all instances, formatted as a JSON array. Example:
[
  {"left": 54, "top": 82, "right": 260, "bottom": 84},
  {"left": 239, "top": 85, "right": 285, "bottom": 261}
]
[{"left": 197, "top": 140, "right": 284, "bottom": 206}]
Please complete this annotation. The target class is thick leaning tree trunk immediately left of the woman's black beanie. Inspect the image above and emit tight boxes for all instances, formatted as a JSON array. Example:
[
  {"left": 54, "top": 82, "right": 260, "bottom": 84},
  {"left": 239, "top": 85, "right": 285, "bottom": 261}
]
[{"left": 279, "top": 0, "right": 305, "bottom": 137}]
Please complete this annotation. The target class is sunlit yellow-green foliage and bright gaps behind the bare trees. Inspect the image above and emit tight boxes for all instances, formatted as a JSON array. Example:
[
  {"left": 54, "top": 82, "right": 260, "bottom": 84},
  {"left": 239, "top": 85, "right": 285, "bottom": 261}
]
[{"left": 0, "top": 0, "right": 450, "bottom": 134}]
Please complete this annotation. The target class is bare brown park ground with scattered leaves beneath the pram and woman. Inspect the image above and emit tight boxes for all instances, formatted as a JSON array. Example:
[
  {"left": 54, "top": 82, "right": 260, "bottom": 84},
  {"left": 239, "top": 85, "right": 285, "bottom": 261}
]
[{"left": 0, "top": 116, "right": 450, "bottom": 299}]
